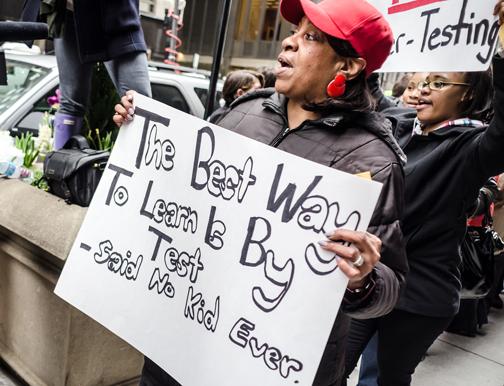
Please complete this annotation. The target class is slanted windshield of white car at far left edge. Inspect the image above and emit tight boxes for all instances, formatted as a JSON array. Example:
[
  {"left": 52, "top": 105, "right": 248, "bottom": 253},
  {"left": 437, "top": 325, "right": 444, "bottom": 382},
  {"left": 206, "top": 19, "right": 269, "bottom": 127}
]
[{"left": 0, "top": 59, "right": 50, "bottom": 114}]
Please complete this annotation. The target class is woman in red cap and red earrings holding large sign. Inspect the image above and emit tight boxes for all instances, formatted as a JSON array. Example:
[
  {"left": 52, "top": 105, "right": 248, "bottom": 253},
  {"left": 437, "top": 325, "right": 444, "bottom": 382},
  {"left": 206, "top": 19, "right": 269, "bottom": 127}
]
[{"left": 115, "top": 0, "right": 407, "bottom": 386}]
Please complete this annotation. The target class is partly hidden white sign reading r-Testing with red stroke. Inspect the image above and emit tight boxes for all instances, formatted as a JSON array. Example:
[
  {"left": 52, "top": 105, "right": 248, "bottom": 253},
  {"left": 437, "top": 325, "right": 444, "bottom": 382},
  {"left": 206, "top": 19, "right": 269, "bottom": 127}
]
[{"left": 368, "top": 0, "right": 499, "bottom": 72}]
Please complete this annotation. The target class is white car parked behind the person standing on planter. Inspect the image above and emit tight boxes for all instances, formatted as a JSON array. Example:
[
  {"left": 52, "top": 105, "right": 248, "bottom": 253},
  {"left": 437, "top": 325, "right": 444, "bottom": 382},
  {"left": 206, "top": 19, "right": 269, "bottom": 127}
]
[{"left": 0, "top": 51, "right": 222, "bottom": 136}]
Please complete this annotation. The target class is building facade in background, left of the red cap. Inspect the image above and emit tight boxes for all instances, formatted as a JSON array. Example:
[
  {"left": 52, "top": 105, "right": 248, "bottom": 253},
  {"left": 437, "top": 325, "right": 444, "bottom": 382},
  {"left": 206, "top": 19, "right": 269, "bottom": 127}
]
[{"left": 141, "top": 0, "right": 291, "bottom": 70}]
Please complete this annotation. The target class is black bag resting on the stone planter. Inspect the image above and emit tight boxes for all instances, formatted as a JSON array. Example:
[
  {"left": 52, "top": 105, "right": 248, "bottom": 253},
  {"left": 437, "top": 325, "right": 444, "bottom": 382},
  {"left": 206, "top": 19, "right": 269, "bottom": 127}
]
[{"left": 44, "top": 135, "right": 110, "bottom": 206}]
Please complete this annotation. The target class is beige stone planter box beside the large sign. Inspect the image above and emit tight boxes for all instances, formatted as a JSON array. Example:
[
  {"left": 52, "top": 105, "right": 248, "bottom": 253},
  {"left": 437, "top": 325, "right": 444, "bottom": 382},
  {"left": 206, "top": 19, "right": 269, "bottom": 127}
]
[{"left": 0, "top": 179, "right": 143, "bottom": 386}]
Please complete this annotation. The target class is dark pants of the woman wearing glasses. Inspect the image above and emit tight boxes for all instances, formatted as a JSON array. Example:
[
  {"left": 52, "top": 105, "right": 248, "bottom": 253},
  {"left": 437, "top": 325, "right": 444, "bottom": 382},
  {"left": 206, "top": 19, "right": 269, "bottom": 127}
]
[{"left": 345, "top": 310, "right": 452, "bottom": 386}]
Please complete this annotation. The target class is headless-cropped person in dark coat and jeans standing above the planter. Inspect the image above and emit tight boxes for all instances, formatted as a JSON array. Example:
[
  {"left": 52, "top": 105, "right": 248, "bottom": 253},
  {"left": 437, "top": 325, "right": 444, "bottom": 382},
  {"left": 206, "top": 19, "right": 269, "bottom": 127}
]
[{"left": 21, "top": 0, "right": 151, "bottom": 149}]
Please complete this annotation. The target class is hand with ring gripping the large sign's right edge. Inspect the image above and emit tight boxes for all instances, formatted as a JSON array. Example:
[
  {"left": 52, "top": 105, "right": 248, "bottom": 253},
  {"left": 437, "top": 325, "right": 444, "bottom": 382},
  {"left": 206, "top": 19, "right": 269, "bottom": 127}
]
[{"left": 319, "top": 229, "right": 382, "bottom": 290}]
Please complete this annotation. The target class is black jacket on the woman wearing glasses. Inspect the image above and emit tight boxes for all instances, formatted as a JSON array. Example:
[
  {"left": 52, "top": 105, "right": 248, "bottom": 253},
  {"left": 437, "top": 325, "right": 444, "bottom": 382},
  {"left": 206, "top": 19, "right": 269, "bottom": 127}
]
[{"left": 372, "top": 57, "right": 504, "bottom": 317}]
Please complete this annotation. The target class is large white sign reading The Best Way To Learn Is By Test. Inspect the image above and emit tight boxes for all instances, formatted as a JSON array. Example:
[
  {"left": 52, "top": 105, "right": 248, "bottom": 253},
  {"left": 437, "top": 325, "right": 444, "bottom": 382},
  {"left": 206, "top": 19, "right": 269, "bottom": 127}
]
[{"left": 55, "top": 95, "right": 381, "bottom": 386}]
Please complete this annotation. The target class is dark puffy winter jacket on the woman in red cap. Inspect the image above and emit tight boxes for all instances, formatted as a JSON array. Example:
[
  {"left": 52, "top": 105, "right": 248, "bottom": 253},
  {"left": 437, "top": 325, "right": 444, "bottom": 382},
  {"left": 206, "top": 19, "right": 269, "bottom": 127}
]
[{"left": 217, "top": 89, "right": 407, "bottom": 386}]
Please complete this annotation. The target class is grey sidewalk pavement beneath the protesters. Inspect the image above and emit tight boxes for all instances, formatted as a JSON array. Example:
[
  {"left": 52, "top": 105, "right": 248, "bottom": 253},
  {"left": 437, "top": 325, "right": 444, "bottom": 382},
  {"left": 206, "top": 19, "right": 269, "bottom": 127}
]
[{"left": 0, "top": 302, "right": 504, "bottom": 386}]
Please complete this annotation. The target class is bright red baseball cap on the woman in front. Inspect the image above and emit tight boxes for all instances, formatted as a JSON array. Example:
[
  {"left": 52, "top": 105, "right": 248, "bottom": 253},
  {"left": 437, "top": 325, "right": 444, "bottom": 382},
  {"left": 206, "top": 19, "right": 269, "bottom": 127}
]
[{"left": 280, "top": 0, "right": 394, "bottom": 75}]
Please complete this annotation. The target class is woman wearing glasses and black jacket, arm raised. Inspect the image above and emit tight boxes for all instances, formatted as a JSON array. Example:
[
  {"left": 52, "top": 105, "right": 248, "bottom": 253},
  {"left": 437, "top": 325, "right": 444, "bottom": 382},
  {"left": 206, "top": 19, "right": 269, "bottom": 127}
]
[{"left": 346, "top": 0, "right": 504, "bottom": 386}]
